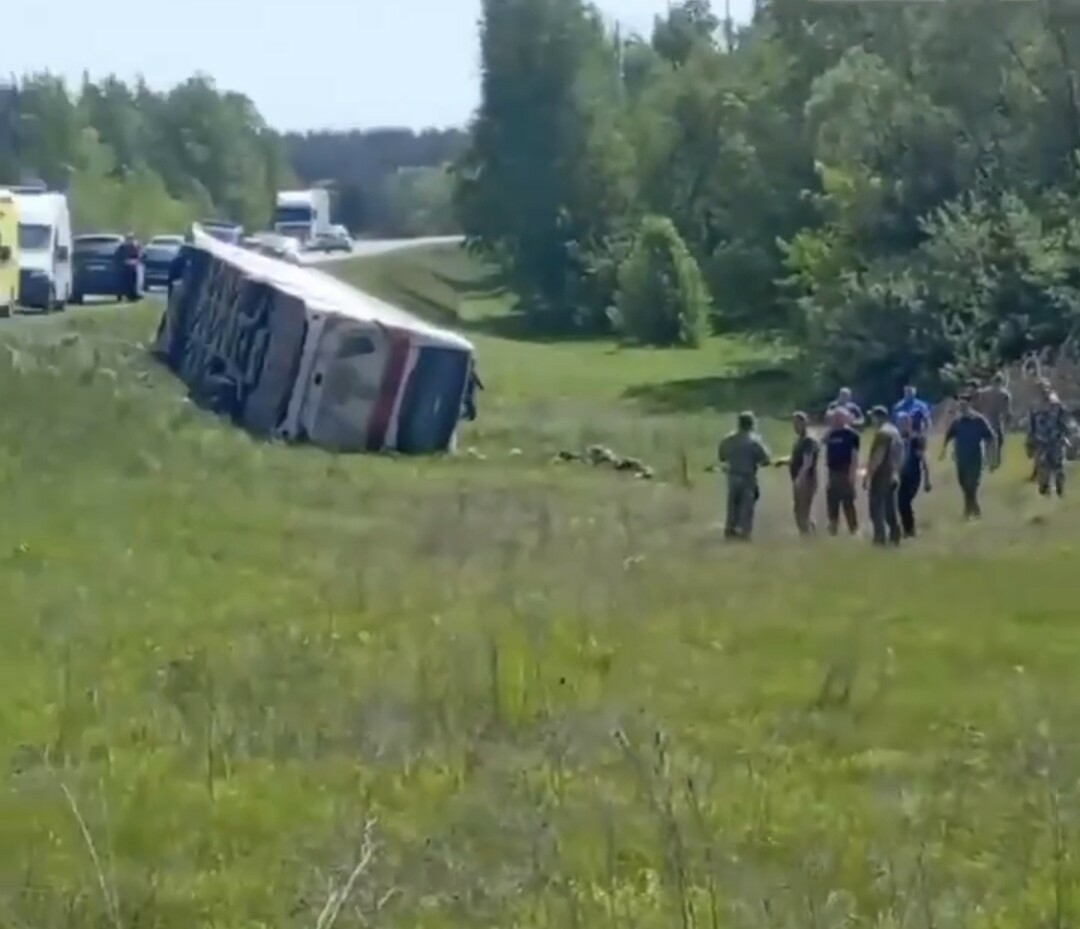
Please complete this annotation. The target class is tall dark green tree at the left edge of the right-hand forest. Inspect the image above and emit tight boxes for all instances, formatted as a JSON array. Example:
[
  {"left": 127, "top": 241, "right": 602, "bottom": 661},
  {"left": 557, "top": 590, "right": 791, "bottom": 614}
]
[{"left": 457, "top": 0, "right": 635, "bottom": 329}]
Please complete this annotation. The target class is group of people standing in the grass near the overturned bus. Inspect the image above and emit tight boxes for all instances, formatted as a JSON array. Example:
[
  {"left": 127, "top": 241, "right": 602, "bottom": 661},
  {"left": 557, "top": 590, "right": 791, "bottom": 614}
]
[{"left": 718, "top": 374, "right": 1070, "bottom": 546}]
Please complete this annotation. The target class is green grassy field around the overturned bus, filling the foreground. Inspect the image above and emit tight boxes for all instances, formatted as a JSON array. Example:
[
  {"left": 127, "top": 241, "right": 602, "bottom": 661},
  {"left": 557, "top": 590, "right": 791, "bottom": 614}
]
[{"left": 6, "top": 251, "right": 1080, "bottom": 929}]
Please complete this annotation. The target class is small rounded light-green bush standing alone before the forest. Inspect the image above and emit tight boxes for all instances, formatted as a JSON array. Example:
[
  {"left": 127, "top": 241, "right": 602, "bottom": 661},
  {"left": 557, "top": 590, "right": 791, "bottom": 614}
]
[{"left": 617, "top": 216, "right": 712, "bottom": 348}]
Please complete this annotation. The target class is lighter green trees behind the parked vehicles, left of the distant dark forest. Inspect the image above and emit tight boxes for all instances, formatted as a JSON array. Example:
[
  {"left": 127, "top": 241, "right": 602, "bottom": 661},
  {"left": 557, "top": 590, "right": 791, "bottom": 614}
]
[{"left": 0, "top": 73, "right": 294, "bottom": 237}]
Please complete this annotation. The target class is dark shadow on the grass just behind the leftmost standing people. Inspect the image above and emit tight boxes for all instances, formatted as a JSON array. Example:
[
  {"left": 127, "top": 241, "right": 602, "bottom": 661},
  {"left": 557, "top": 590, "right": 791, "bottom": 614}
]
[{"left": 622, "top": 362, "right": 798, "bottom": 416}]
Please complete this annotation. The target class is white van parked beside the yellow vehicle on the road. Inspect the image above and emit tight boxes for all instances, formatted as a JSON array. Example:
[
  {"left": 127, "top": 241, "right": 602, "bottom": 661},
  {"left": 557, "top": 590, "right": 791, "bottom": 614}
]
[{"left": 14, "top": 187, "right": 71, "bottom": 312}]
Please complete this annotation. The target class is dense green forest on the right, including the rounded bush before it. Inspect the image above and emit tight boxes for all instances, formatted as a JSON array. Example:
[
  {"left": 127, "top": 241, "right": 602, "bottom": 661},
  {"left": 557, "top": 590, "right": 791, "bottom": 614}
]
[{"left": 457, "top": 0, "right": 1080, "bottom": 390}]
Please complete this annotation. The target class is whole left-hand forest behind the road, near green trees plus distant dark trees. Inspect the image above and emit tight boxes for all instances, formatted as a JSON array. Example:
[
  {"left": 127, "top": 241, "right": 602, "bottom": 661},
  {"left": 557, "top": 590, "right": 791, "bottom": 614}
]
[{"left": 0, "top": 73, "right": 467, "bottom": 235}]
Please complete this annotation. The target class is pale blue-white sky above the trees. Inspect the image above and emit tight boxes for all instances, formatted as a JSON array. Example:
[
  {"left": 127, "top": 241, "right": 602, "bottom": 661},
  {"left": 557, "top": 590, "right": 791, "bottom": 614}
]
[{"left": 6, "top": 0, "right": 752, "bottom": 130}]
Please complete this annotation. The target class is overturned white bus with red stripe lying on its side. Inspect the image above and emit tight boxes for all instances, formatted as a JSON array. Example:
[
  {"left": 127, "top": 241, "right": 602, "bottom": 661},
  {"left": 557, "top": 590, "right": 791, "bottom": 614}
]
[{"left": 154, "top": 228, "right": 473, "bottom": 454}]
